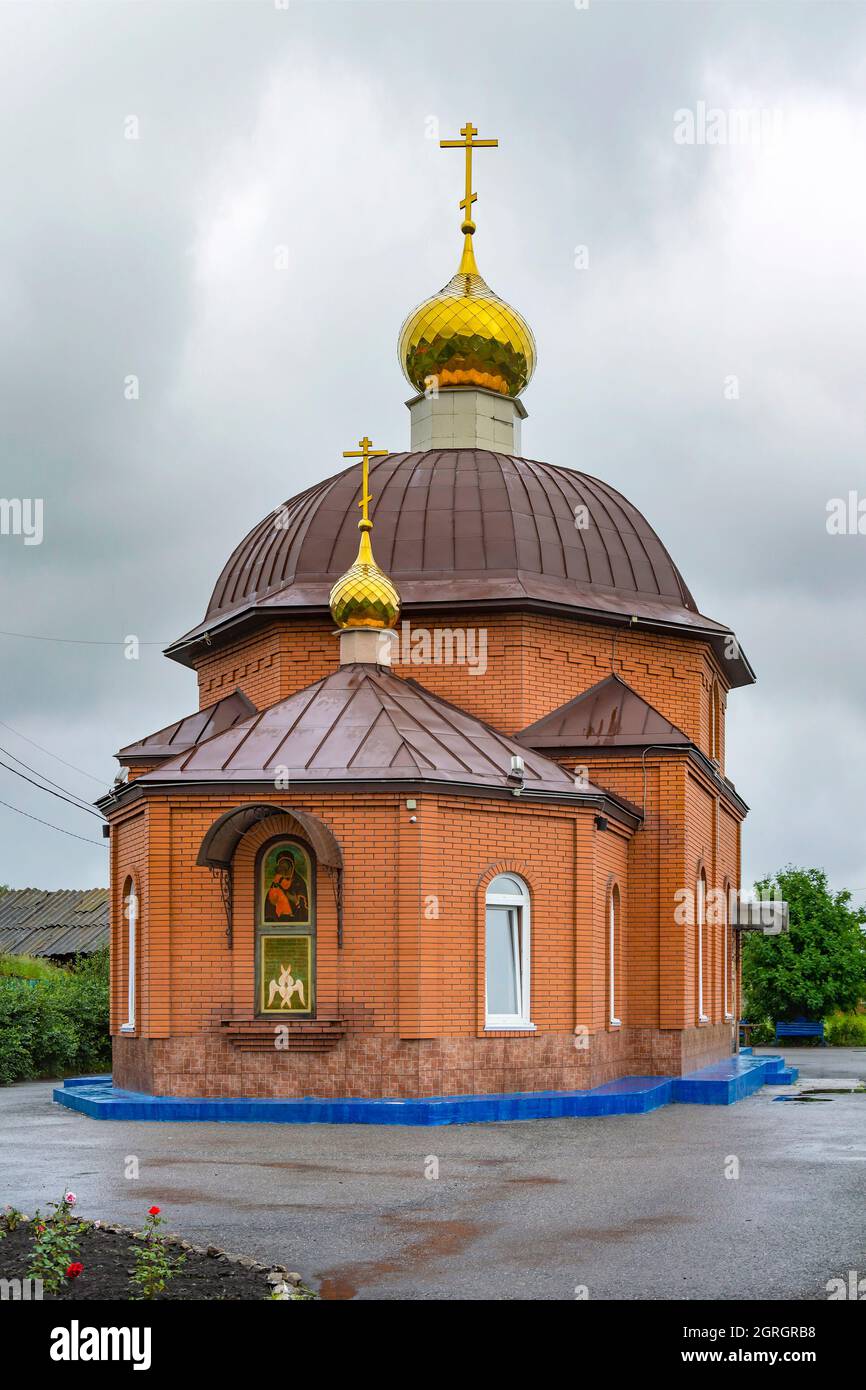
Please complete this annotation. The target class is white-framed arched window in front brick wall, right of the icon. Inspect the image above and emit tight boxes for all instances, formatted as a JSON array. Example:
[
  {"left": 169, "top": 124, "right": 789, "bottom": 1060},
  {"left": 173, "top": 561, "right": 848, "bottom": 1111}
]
[{"left": 484, "top": 873, "right": 532, "bottom": 1029}]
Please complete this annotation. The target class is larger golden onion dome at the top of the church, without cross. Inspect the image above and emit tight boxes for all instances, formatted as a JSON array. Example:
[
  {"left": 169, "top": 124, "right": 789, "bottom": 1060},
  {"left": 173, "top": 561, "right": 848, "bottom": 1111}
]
[{"left": 398, "top": 232, "right": 535, "bottom": 396}]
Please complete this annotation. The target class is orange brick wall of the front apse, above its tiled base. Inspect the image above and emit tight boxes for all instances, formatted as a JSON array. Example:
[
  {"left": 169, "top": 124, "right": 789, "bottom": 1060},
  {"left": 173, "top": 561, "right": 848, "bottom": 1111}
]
[{"left": 113, "top": 792, "right": 628, "bottom": 1037}]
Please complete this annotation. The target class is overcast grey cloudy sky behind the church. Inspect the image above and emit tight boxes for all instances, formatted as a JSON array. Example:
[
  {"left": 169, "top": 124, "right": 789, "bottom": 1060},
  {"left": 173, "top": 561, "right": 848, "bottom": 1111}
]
[{"left": 0, "top": 0, "right": 866, "bottom": 902}]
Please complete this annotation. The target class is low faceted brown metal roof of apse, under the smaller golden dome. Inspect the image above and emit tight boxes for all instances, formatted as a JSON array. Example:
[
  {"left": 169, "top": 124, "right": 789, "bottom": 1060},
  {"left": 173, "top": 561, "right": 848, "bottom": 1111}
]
[{"left": 132, "top": 664, "right": 631, "bottom": 799}]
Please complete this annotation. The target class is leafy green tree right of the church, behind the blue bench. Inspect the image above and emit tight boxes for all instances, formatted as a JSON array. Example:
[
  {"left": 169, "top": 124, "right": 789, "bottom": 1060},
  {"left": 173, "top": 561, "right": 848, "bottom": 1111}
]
[{"left": 742, "top": 865, "right": 866, "bottom": 1022}]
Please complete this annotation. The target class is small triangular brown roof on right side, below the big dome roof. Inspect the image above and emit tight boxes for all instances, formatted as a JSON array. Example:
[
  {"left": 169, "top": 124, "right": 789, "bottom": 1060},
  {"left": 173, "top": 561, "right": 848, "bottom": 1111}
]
[{"left": 514, "top": 674, "right": 692, "bottom": 748}]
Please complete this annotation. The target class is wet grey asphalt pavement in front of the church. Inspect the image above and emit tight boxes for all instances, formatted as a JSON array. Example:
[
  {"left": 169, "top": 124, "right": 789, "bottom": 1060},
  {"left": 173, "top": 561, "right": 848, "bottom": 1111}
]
[{"left": 0, "top": 1049, "right": 866, "bottom": 1300}]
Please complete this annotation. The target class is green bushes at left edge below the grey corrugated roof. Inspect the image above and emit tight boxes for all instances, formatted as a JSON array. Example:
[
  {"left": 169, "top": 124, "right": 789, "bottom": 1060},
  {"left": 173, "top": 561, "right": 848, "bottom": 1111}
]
[{"left": 0, "top": 952, "right": 111, "bottom": 1086}]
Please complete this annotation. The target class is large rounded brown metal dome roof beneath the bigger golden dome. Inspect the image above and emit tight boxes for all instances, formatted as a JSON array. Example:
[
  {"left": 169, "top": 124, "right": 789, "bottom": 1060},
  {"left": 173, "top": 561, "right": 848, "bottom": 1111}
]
[{"left": 168, "top": 449, "right": 752, "bottom": 684}]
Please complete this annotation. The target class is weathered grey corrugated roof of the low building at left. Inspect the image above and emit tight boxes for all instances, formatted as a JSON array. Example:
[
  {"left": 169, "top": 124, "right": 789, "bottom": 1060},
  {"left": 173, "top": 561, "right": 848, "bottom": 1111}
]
[{"left": 0, "top": 888, "right": 108, "bottom": 956}]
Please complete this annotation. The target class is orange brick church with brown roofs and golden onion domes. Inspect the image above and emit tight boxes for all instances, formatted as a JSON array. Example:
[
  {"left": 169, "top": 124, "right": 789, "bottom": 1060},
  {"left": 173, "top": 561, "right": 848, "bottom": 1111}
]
[{"left": 100, "top": 124, "right": 753, "bottom": 1099}]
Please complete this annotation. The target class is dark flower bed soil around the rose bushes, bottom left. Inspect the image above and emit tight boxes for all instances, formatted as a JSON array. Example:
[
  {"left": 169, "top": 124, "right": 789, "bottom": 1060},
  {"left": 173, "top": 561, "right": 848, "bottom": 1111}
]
[{"left": 0, "top": 1220, "right": 313, "bottom": 1302}]
